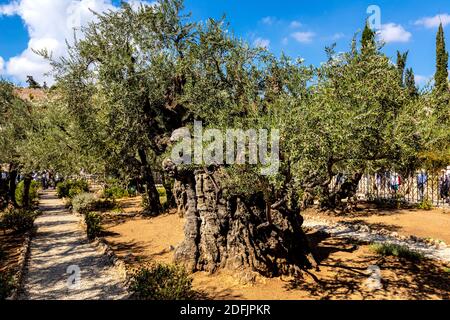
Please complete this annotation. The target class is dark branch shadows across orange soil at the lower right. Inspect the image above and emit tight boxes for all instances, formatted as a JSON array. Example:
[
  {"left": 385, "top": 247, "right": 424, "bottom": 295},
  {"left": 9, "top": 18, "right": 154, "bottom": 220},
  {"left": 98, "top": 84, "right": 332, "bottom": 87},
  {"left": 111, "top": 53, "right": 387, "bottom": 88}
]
[{"left": 285, "top": 234, "right": 450, "bottom": 300}]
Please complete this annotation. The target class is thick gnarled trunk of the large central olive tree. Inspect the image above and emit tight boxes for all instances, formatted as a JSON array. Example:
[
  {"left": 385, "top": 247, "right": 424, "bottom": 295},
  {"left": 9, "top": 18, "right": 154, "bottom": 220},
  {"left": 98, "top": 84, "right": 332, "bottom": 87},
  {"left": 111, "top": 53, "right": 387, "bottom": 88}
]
[{"left": 164, "top": 161, "right": 316, "bottom": 277}]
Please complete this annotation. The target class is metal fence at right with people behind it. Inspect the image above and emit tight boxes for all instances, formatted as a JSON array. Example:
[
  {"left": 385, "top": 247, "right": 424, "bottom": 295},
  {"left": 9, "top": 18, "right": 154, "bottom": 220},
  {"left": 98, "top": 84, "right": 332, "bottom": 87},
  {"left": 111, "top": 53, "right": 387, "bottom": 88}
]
[{"left": 331, "top": 171, "right": 450, "bottom": 207}]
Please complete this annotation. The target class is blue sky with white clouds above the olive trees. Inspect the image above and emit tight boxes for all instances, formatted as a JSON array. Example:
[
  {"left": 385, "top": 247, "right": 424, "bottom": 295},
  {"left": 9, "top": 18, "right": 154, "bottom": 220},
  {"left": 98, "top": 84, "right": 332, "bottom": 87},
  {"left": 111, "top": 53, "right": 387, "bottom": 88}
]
[{"left": 0, "top": 0, "right": 450, "bottom": 84}]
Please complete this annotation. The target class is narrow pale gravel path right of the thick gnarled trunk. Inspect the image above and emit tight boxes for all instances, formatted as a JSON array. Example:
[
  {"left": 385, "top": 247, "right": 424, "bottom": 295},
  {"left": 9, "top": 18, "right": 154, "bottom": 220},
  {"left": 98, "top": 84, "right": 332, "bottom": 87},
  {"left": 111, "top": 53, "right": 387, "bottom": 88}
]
[{"left": 303, "top": 217, "right": 450, "bottom": 263}]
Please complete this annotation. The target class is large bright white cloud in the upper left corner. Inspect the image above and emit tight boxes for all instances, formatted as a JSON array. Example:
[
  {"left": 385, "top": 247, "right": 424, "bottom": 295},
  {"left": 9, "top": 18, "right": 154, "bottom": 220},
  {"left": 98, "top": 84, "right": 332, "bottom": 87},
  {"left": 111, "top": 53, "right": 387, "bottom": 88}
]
[{"left": 0, "top": 0, "right": 152, "bottom": 84}]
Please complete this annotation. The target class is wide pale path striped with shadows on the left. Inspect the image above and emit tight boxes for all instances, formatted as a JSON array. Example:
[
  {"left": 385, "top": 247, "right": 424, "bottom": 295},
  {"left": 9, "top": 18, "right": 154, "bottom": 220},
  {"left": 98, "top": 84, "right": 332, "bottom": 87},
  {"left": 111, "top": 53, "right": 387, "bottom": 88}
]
[{"left": 20, "top": 191, "right": 127, "bottom": 300}]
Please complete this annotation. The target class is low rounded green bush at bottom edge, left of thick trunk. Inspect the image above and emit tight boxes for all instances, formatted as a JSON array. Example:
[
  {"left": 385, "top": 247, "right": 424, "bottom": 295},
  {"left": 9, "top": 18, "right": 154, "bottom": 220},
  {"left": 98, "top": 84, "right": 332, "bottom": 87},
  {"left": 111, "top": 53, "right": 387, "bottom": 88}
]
[{"left": 130, "top": 264, "right": 194, "bottom": 300}]
